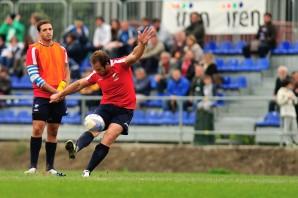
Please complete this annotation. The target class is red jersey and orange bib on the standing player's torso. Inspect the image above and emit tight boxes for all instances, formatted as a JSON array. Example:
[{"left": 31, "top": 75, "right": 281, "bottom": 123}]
[{"left": 26, "top": 42, "right": 68, "bottom": 98}]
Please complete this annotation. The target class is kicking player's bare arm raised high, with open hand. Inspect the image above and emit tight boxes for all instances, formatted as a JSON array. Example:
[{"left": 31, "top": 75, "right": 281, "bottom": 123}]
[{"left": 125, "top": 27, "right": 156, "bottom": 65}]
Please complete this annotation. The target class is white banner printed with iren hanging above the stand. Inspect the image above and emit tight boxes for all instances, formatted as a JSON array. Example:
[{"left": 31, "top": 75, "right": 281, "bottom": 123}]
[{"left": 162, "top": 0, "right": 266, "bottom": 34}]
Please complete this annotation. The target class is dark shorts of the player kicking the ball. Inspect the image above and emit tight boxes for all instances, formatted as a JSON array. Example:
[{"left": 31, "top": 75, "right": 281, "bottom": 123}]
[{"left": 94, "top": 104, "right": 133, "bottom": 135}]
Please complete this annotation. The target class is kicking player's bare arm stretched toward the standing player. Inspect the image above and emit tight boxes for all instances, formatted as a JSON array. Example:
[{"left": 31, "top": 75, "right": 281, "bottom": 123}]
[{"left": 50, "top": 78, "right": 92, "bottom": 103}]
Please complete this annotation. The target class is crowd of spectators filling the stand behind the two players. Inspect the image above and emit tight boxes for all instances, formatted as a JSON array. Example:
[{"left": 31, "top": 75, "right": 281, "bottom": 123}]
[{"left": 0, "top": 12, "right": 276, "bottom": 117}]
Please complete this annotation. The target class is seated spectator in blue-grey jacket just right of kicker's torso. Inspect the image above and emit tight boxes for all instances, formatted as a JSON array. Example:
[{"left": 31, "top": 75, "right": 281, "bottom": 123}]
[{"left": 134, "top": 67, "right": 151, "bottom": 103}]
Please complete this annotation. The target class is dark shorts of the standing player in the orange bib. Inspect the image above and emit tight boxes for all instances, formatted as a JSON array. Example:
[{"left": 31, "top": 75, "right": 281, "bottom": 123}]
[{"left": 32, "top": 97, "right": 67, "bottom": 123}]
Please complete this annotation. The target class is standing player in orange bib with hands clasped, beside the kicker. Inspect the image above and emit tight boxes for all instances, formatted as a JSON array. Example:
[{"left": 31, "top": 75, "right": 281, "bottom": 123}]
[{"left": 25, "top": 20, "right": 70, "bottom": 176}]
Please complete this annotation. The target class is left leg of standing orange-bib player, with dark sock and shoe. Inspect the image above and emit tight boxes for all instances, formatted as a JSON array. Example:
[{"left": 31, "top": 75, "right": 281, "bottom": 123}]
[{"left": 24, "top": 120, "right": 46, "bottom": 174}]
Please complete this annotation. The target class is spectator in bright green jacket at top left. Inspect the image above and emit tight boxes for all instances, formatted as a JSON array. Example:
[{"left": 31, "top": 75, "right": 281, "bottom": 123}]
[{"left": 0, "top": 14, "right": 25, "bottom": 43}]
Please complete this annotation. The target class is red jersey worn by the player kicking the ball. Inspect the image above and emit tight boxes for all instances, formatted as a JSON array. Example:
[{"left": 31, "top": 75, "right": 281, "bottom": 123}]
[{"left": 87, "top": 58, "right": 136, "bottom": 109}]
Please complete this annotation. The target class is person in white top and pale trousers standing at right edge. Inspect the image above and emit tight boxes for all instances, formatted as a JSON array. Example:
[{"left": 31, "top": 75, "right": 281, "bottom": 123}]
[{"left": 277, "top": 78, "right": 298, "bottom": 146}]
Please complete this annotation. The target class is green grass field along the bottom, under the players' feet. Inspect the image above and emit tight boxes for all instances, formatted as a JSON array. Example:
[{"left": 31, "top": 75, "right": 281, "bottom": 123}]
[{"left": 0, "top": 171, "right": 298, "bottom": 198}]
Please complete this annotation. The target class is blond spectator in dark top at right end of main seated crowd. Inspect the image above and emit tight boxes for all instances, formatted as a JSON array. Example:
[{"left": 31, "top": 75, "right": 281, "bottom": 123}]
[{"left": 200, "top": 53, "right": 222, "bottom": 88}]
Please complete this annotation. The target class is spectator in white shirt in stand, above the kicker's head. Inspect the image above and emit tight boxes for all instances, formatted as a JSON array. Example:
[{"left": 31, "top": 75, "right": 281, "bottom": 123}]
[{"left": 93, "top": 16, "right": 112, "bottom": 49}]
